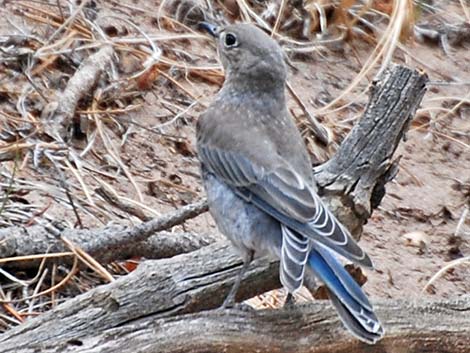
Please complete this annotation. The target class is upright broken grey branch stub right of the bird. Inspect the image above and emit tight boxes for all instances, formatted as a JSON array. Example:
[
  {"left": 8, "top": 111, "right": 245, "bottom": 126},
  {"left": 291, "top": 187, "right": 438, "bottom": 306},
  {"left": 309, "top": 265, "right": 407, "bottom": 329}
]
[{"left": 315, "top": 65, "right": 428, "bottom": 239}]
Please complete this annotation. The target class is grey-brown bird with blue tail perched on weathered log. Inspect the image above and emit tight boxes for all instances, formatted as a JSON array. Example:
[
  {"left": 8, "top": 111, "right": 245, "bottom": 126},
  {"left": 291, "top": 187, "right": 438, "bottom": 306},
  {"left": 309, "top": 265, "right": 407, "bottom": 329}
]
[{"left": 196, "top": 22, "right": 384, "bottom": 344}]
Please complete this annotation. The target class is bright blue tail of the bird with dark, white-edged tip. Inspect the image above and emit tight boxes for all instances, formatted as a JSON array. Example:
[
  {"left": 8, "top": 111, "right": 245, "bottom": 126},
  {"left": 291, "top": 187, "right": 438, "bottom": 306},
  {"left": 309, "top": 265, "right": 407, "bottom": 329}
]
[{"left": 308, "top": 245, "right": 384, "bottom": 344}]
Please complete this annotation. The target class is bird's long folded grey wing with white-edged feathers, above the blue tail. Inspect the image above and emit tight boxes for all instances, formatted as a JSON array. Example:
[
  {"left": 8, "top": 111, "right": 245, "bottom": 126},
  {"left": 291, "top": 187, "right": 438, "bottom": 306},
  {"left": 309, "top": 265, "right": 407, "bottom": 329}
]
[{"left": 198, "top": 144, "right": 372, "bottom": 267}]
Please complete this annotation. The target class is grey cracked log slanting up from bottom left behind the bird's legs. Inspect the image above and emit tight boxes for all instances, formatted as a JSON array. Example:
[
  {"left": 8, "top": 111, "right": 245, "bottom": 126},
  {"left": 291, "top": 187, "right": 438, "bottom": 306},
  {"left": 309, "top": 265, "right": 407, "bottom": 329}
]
[{"left": 0, "top": 242, "right": 280, "bottom": 352}]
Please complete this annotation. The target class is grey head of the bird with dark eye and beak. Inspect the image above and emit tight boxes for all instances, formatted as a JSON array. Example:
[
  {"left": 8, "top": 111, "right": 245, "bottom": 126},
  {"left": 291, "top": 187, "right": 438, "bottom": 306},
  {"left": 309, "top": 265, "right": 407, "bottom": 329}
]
[{"left": 200, "top": 22, "right": 286, "bottom": 89}]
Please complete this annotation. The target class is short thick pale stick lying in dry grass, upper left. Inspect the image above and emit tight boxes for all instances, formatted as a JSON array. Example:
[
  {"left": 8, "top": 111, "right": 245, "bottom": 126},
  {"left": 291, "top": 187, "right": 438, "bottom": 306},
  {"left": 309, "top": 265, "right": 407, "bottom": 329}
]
[{"left": 41, "top": 45, "right": 114, "bottom": 141}]
